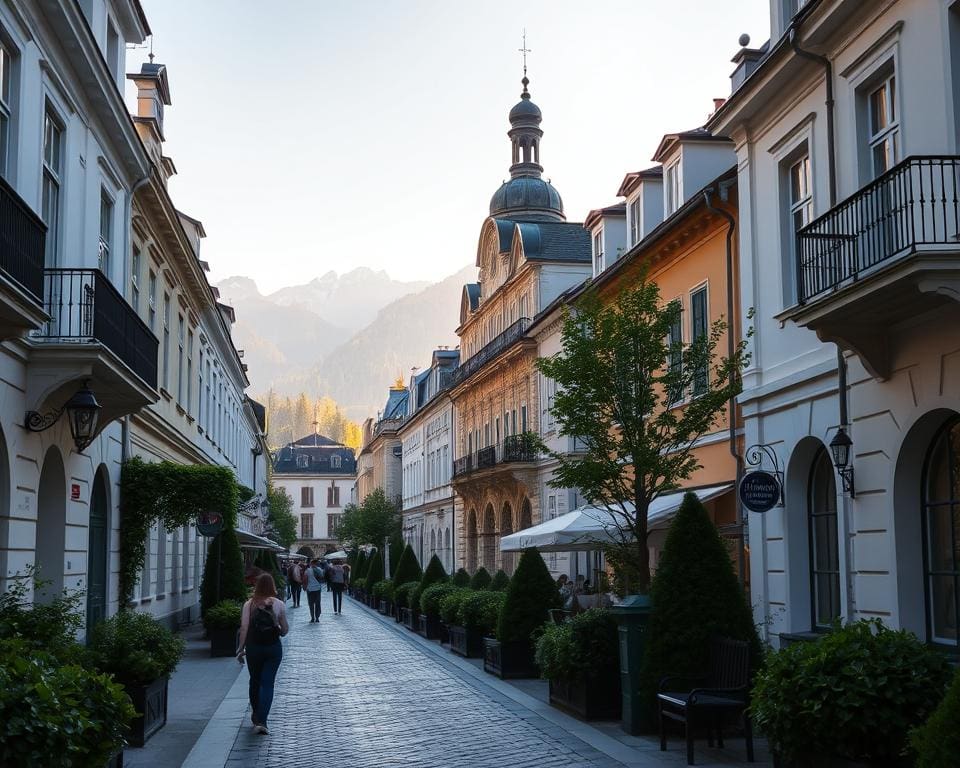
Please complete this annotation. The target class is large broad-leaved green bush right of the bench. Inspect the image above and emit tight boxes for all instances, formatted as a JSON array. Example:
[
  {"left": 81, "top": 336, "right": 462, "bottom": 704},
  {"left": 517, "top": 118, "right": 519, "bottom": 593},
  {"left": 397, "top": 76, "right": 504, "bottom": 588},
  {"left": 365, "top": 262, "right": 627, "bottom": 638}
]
[{"left": 751, "top": 619, "right": 956, "bottom": 765}]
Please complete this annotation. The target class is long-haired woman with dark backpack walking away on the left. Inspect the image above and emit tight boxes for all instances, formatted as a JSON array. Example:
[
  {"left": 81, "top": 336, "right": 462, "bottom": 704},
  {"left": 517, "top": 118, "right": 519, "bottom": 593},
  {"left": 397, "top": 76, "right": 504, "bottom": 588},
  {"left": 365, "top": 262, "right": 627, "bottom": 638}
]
[{"left": 237, "top": 573, "right": 290, "bottom": 735}]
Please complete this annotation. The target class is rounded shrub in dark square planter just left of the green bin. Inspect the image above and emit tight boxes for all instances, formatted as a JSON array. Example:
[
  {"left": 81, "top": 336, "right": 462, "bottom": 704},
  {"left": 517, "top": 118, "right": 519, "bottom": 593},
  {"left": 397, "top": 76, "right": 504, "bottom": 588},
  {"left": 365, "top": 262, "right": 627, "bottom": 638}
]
[{"left": 535, "top": 608, "right": 621, "bottom": 720}]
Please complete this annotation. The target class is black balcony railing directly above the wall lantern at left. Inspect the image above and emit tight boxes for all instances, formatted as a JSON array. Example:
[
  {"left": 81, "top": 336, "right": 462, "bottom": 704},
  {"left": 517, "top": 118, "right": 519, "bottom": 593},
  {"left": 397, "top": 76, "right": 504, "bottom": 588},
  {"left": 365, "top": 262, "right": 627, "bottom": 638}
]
[{"left": 34, "top": 269, "right": 159, "bottom": 389}]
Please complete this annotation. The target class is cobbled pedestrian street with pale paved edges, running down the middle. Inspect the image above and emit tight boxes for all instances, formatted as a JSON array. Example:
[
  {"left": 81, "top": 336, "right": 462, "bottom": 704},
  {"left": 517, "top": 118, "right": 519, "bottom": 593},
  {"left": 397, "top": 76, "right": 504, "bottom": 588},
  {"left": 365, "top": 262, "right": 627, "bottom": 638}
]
[{"left": 184, "top": 599, "right": 769, "bottom": 768}]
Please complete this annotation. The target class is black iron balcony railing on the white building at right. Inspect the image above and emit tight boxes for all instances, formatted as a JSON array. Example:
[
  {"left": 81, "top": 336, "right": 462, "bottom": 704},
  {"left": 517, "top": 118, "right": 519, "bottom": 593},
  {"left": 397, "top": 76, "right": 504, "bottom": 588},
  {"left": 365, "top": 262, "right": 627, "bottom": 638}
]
[{"left": 797, "top": 156, "right": 960, "bottom": 304}]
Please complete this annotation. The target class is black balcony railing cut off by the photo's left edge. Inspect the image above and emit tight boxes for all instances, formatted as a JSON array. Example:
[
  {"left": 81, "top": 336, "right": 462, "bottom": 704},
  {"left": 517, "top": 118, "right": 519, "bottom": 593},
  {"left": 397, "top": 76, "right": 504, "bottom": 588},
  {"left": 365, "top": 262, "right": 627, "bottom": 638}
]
[{"left": 0, "top": 176, "right": 47, "bottom": 304}]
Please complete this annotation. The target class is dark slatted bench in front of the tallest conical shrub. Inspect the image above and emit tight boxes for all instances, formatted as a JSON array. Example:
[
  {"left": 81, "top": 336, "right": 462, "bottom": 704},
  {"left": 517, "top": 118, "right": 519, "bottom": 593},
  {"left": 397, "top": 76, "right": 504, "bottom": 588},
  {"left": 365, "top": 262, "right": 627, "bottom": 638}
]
[{"left": 657, "top": 637, "right": 753, "bottom": 765}]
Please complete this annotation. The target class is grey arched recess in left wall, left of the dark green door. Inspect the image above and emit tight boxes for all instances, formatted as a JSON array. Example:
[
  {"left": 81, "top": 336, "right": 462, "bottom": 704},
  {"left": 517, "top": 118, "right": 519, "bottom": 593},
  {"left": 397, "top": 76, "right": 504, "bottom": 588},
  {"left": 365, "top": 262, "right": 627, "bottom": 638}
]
[{"left": 34, "top": 446, "right": 67, "bottom": 603}]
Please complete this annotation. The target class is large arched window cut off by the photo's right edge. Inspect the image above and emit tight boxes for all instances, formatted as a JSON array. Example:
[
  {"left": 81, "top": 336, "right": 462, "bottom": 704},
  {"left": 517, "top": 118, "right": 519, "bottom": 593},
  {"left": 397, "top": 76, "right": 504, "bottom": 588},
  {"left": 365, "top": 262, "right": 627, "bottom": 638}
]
[{"left": 923, "top": 419, "right": 960, "bottom": 648}]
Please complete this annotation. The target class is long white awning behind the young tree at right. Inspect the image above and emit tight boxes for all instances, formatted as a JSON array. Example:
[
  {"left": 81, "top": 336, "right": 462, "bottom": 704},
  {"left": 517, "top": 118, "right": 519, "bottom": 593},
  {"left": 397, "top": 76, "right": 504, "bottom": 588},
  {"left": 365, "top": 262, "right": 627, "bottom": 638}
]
[{"left": 500, "top": 483, "right": 733, "bottom": 552}]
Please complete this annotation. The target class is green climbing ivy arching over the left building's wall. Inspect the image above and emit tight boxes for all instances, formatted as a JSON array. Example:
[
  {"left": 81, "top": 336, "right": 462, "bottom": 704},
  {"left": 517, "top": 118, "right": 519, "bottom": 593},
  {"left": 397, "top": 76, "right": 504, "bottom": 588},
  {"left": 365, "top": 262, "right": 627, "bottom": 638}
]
[{"left": 120, "top": 457, "right": 239, "bottom": 606}]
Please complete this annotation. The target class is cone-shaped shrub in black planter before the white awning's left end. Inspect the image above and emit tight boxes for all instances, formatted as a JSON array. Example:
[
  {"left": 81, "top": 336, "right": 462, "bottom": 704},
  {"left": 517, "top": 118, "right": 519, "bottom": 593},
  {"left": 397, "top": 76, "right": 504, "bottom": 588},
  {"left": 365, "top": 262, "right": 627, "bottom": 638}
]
[{"left": 483, "top": 547, "right": 560, "bottom": 678}]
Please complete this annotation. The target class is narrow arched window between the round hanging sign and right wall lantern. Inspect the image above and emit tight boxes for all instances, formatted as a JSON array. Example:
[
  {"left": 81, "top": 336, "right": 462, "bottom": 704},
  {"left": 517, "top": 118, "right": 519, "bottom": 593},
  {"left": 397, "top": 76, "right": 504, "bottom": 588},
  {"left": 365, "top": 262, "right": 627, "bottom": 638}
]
[{"left": 807, "top": 448, "right": 840, "bottom": 629}]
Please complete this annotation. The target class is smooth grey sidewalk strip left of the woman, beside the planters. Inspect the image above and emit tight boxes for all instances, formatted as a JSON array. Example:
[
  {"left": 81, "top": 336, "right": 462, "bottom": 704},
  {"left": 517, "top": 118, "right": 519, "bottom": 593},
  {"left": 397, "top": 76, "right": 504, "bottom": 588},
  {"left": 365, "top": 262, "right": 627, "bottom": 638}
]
[{"left": 123, "top": 622, "right": 240, "bottom": 768}]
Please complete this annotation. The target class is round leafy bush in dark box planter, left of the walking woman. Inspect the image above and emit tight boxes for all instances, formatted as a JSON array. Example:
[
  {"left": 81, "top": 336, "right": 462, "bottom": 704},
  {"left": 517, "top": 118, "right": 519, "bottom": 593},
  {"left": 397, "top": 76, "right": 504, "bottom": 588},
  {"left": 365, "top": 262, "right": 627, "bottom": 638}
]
[{"left": 90, "top": 611, "right": 184, "bottom": 747}]
